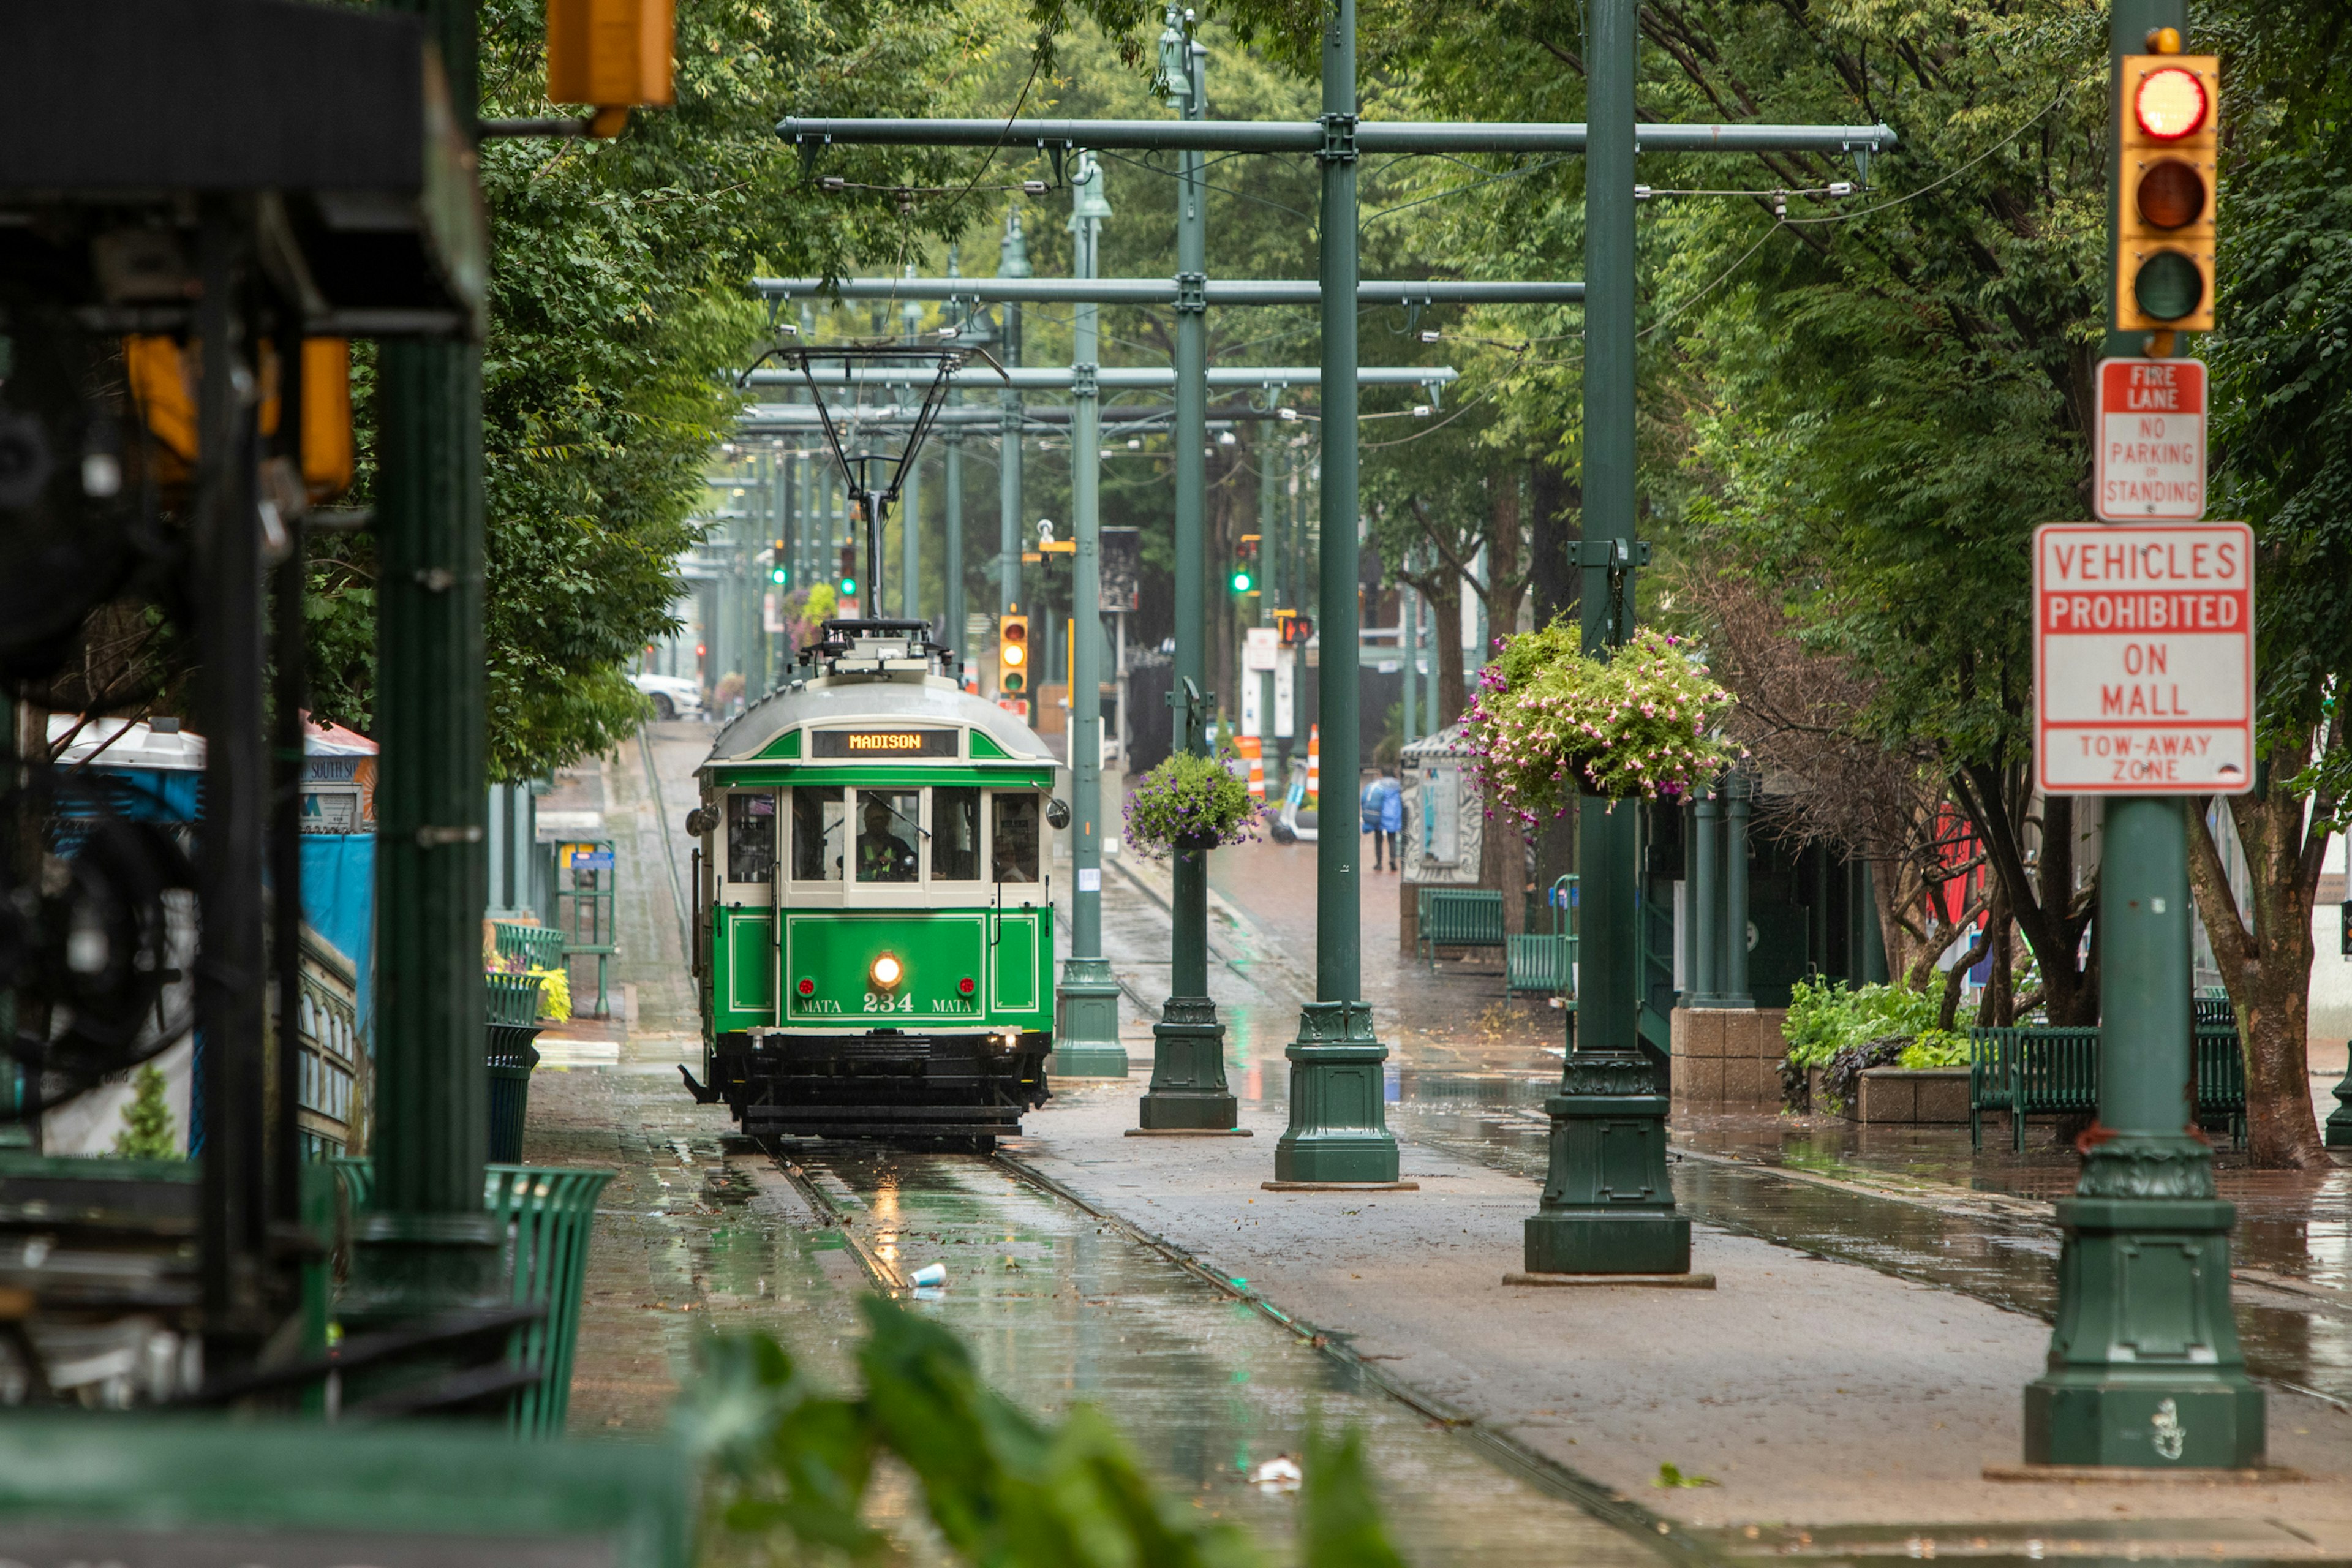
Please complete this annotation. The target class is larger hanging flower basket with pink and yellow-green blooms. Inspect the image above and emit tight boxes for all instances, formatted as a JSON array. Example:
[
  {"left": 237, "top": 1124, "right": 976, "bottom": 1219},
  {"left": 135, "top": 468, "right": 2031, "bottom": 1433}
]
[{"left": 1468, "top": 620, "right": 1745, "bottom": 825}]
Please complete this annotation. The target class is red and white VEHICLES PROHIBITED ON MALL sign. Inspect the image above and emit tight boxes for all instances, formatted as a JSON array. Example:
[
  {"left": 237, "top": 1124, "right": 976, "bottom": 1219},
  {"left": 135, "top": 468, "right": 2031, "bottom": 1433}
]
[{"left": 2035, "top": 522, "right": 2253, "bottom": 794}]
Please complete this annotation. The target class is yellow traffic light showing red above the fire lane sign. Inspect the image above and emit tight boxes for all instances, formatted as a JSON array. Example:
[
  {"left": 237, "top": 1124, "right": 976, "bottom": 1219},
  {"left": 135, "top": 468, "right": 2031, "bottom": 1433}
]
[{"left": 2114, "top": 46, "right": 2220, "bottom": 331}]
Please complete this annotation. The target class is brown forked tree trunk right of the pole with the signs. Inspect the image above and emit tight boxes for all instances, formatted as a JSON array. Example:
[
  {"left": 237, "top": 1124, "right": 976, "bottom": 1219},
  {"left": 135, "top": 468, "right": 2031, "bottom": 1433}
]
[{"left": 2190, "top": 722, "right": 2335, "bottom": 1170}]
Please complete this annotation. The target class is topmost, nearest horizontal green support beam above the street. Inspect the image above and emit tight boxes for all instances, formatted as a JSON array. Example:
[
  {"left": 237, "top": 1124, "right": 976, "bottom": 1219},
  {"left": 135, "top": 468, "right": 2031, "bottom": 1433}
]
[{"left": 776, "top": 118, "right": 1898, "bottom": 153}]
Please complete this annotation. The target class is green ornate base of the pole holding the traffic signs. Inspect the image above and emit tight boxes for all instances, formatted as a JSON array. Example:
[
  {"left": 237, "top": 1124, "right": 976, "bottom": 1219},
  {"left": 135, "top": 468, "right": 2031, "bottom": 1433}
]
[{"left": 2025, "top": 1138, "right": 2265, "bottom": 1469}]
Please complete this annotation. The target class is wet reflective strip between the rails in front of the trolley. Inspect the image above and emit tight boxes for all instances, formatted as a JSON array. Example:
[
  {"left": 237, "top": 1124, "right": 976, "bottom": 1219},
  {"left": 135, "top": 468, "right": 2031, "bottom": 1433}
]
[{"left": 783, "top": 1145, "right": 1658, "bottom": 1568}]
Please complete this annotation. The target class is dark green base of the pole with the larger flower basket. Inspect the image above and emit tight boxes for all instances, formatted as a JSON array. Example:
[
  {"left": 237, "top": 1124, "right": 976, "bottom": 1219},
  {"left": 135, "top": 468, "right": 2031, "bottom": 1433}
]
[{"left": 1524, "top": 1051, "right": 1691, "bottom": 1274}]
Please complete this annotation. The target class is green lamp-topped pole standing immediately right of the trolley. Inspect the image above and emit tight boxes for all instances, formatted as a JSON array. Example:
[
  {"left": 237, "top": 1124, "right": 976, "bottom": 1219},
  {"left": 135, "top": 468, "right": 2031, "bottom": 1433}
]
[{"left": 1047, "top": 153, "right": 1126, "bottom": 1079}]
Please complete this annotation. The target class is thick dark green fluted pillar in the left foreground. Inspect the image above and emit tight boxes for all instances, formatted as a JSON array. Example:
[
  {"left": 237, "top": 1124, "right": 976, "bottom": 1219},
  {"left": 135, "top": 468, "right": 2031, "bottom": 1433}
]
[{"left": 345, "top": 0, "right": 496, "bottom": 1321}]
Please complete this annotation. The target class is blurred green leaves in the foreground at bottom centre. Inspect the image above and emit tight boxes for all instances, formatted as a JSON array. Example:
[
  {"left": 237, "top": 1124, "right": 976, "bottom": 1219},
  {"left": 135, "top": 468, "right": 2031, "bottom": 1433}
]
[{"left": 677, "top": 1298, "right": 1402, "bottom": 1568}]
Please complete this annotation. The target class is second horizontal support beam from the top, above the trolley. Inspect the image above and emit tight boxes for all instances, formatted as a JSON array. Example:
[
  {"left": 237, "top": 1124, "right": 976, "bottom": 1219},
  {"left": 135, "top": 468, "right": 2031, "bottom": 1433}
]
[{"left": 750, "top": 277, "right": 1585, "bottom": 306}]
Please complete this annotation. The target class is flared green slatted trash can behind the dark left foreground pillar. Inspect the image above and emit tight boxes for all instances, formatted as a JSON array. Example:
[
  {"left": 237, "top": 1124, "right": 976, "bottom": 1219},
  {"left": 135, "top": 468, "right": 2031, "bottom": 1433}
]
[{"left": 331, "top": 1156, "right": 614, "bottom": 1436}]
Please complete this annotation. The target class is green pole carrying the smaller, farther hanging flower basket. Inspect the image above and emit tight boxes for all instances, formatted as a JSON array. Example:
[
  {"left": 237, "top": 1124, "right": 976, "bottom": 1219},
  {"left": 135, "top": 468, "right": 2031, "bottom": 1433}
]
[{"left": 1136, "top": 5, "right": 1242, "bottom": 1131}]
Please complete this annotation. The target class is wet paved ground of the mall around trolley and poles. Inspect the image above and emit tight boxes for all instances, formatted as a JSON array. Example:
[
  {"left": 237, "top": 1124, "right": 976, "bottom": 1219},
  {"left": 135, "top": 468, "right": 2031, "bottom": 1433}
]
[{"left": 527, "top": 724, "right": 2352, "bottom": 1563}]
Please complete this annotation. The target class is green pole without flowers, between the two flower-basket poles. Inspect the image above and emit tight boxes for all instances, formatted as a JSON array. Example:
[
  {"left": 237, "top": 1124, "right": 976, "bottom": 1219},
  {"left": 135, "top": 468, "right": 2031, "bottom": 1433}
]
[{"left": 1275, "top": 0, "right": 1397, "bottom": 1183}]
